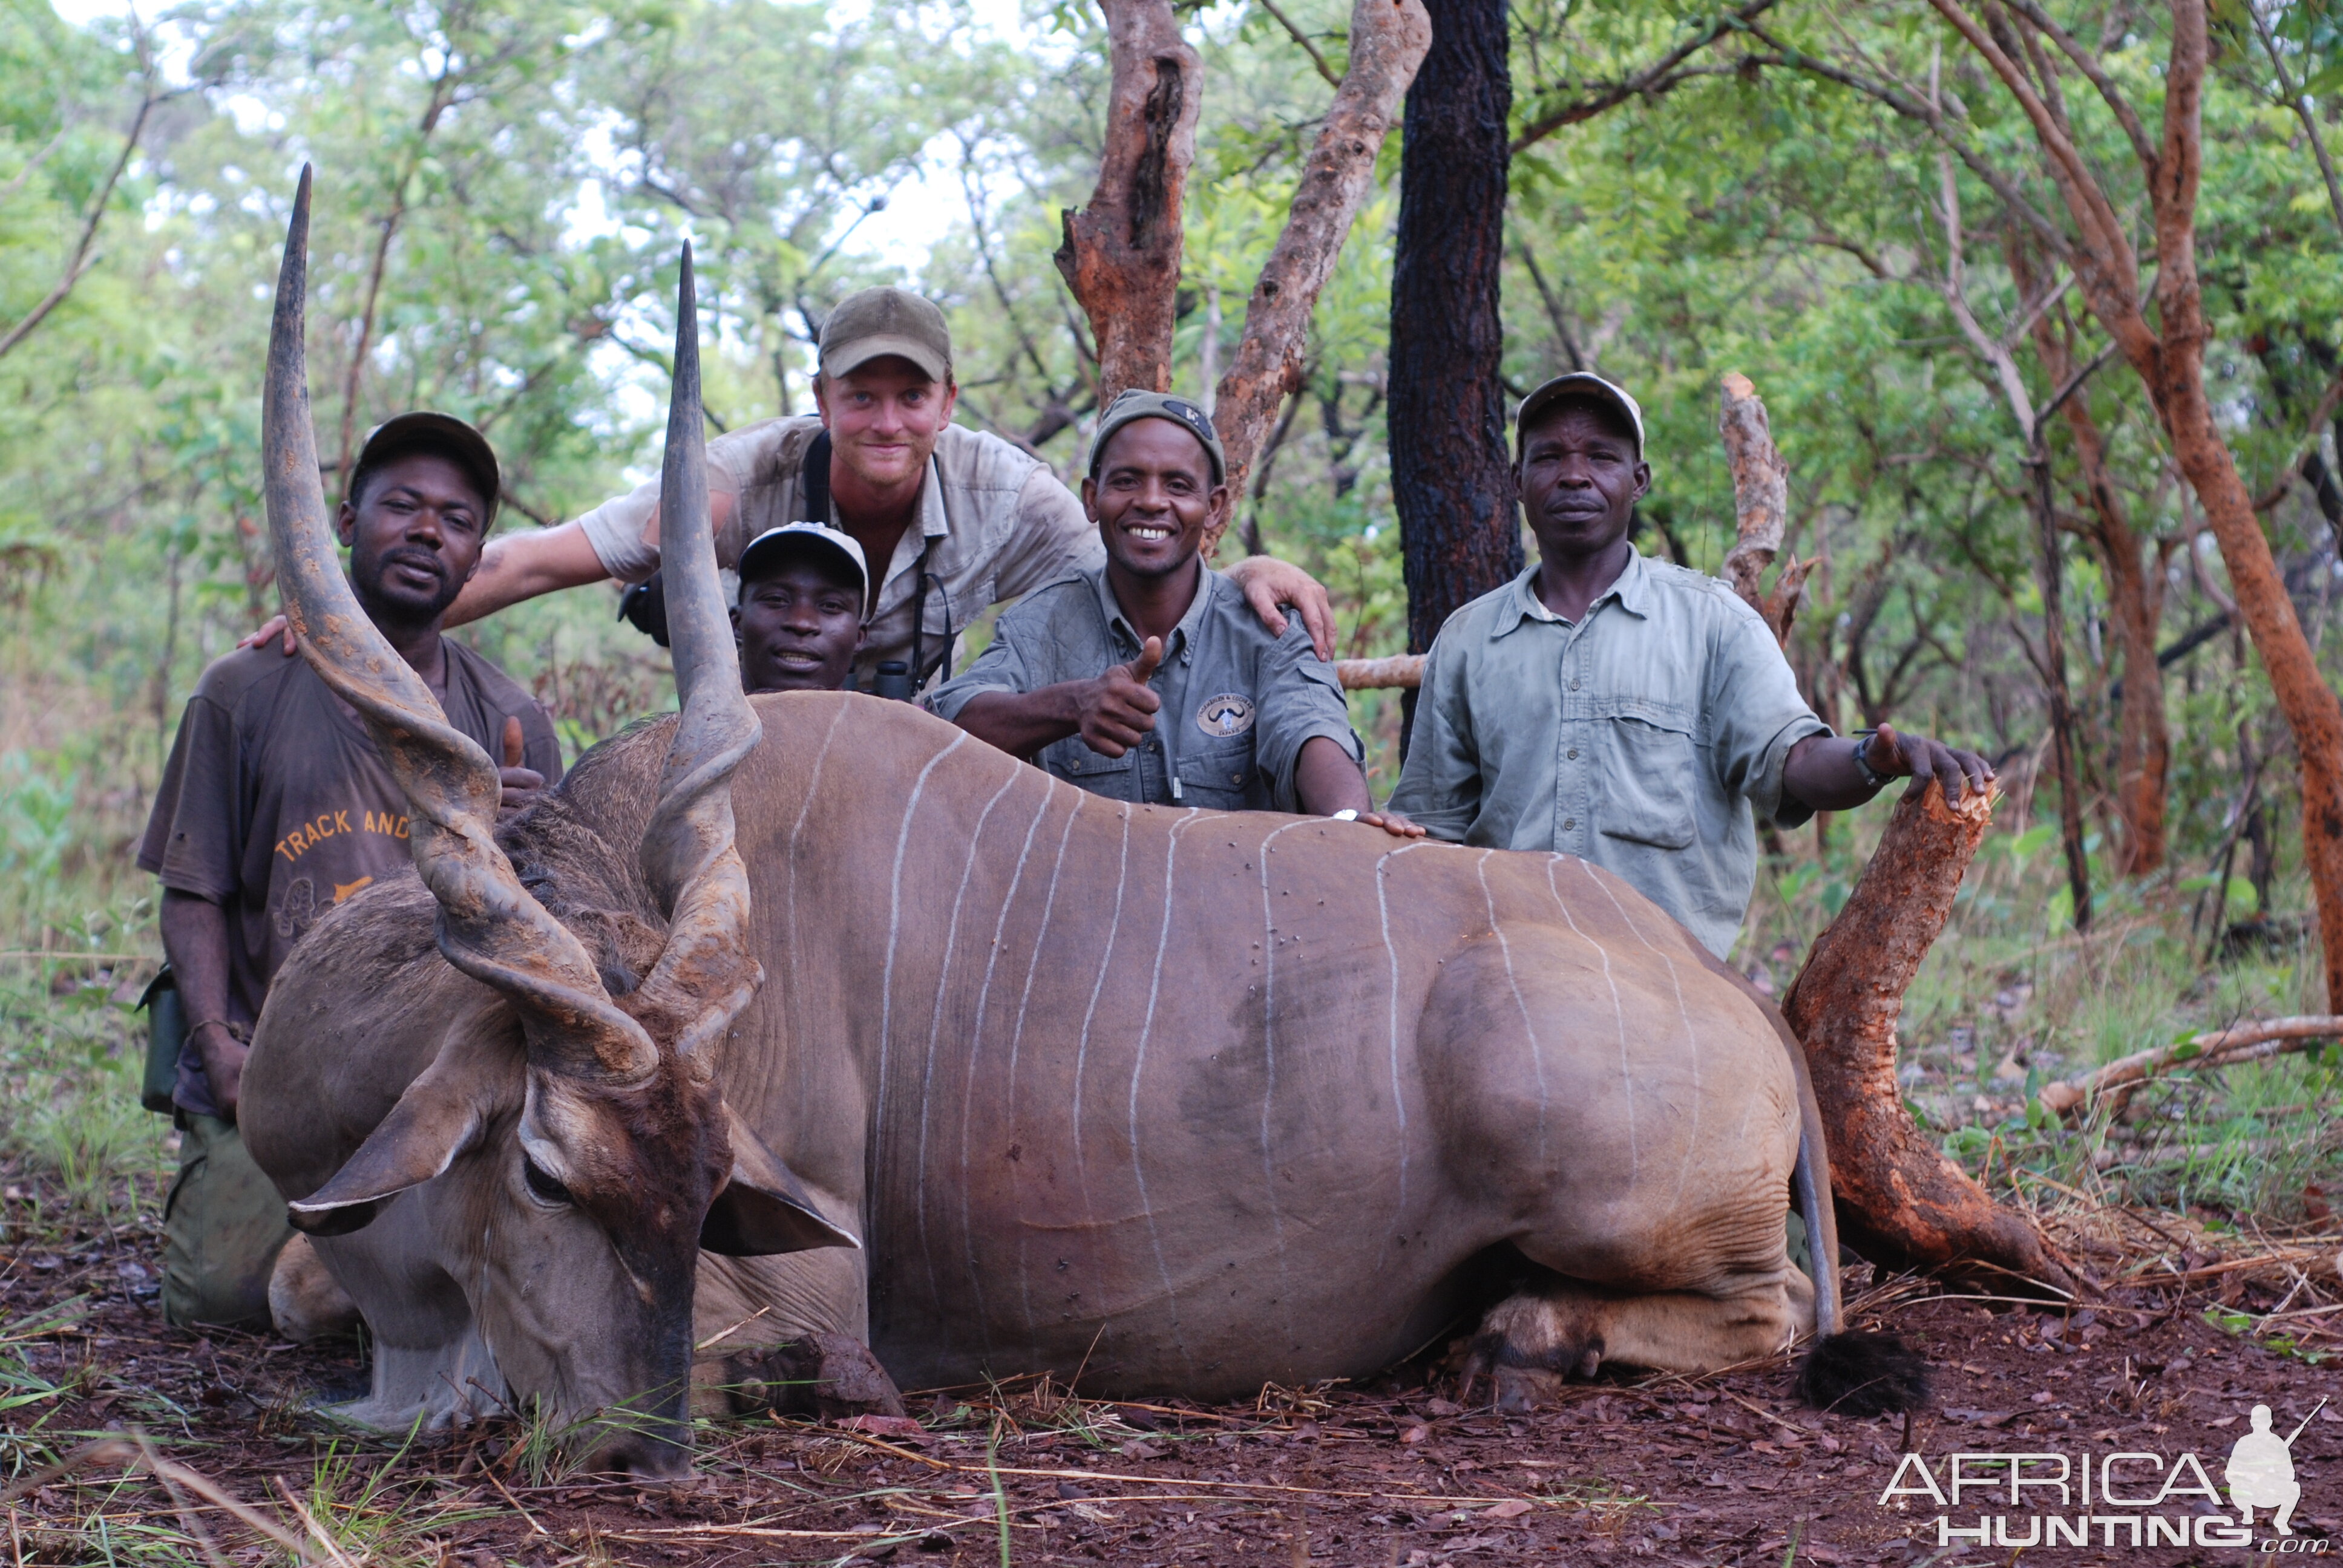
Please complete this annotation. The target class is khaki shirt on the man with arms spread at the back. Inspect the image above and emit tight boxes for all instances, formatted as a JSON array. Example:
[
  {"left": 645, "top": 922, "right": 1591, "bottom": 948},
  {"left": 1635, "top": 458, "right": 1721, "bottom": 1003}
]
[{"left": 578, "top": 415, "right": 1106, "bottom": 691}]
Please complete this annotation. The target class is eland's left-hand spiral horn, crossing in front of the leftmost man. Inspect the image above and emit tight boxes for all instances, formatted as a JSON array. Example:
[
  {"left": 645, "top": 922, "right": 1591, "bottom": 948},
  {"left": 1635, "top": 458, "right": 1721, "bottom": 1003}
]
[{"left": 260, "top": 166, "right": 658, "bottom": 1083}]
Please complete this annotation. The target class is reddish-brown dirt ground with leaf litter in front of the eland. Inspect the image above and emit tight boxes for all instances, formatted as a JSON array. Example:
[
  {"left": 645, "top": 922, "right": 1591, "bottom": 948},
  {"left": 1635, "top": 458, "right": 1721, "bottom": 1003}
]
[{"left": 0, "top": 1193, "right": 2343, "bottom": 1568}]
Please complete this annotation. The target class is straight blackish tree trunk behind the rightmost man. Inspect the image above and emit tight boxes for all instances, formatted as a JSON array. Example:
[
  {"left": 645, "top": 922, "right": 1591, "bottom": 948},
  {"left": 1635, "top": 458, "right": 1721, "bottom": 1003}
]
[{"left": 1387, "top": 0, "right": 1523, "bottom": 654}]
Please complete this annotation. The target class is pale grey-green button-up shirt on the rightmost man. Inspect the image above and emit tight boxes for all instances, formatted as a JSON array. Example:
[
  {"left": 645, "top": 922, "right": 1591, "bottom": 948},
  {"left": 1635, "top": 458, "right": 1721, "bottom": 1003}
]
[{"left": 1392, "top": 553, "right": 1830, "bottom": 959}]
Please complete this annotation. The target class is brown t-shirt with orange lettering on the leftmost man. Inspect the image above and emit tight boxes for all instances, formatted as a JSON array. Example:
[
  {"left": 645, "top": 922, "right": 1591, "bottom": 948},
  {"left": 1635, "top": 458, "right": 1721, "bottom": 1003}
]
[{"left": 138, "top": 640, "right": 562, "bottom": 1116}]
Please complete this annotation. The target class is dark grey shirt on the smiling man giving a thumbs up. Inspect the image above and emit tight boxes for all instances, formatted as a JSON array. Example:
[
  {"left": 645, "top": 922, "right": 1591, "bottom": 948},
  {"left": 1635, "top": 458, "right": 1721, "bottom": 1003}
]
[{"left": 928, "top": 563, "right": 1364, "bottom": 811}]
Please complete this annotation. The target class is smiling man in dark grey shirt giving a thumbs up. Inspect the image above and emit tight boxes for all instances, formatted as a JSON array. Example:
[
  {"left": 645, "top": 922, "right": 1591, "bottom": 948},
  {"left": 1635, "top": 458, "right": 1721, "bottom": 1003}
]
[{"left": 928, "top": 391, "right": 1422, "bottom": 837}]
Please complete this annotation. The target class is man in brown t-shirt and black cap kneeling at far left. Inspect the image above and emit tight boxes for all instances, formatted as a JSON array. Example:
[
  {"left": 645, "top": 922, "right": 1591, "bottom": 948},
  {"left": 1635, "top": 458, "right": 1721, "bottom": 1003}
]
[{"left": 138, "top": 413, "right": 560, "bottom": 1324}]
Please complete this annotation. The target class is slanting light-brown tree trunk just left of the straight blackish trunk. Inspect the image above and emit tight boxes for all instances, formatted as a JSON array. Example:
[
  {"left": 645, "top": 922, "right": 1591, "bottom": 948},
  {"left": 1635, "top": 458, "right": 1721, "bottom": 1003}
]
[{"left": 1204, "top": 0, "right": 1432, "bottom": 553}]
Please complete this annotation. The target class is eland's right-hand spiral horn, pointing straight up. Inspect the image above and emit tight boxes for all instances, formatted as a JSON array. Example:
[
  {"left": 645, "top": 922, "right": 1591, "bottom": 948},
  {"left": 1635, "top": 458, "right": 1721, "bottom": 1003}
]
[{"left": 635, "top": 241, "right": 764, "bottom": 1076}]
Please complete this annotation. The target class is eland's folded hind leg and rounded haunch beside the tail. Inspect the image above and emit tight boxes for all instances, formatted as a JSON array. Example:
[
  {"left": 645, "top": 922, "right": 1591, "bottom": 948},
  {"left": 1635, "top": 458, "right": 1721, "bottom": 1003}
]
[{"left": 1422, "top": 923, "right": 1814, "bottom": 1409}]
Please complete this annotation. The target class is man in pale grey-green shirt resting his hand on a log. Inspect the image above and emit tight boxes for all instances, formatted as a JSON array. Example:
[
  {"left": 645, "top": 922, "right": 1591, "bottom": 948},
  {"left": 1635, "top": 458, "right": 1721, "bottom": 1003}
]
[{"left": 1392, "top": 373, "right": 1994, "bottom": 959}]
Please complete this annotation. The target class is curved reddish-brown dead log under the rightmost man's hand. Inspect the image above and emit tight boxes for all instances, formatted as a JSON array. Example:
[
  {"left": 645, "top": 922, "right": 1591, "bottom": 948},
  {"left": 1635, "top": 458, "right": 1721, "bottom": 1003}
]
[{"left": 1781, "top": 780, "right": 2076, "bottom": 1294}]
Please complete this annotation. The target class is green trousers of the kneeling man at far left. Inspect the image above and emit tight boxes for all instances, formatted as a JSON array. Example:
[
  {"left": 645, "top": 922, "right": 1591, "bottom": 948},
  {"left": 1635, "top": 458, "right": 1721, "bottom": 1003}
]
[{"left": 162, "top": 1111, "right": 293, "bottom": 1329}]
